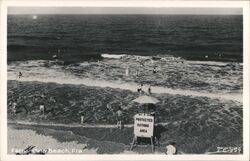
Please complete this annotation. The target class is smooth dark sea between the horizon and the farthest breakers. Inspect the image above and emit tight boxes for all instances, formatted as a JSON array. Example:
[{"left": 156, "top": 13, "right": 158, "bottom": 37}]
[{"left": 8, "top": 15, "right": 243, "bottom": 62}]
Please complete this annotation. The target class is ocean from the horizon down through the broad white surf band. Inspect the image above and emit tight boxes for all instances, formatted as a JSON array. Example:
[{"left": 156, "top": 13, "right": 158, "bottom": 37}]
[{"left": 8, "top": 15, "right": 243, "bottom": 95}]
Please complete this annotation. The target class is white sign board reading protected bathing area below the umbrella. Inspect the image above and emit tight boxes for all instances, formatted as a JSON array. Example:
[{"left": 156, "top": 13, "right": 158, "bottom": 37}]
[{"left": 134, "top": 114, "right": 154, "bottom": 137}]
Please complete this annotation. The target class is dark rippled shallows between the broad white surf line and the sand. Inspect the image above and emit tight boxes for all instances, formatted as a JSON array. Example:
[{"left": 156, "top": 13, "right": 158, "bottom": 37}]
[{"left": 8, "top": 80, "right": 243, "bottom": 154}]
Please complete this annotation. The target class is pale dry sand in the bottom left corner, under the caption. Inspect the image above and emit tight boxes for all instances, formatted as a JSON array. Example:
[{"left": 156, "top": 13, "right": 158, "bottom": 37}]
[{"left": 8, "top": 127, "right": 142, "bottom": 154}]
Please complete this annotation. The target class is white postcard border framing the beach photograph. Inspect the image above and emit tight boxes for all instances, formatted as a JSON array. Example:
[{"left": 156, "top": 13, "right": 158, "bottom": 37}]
[{"left": 0, "top": 0, "right": 250, "bottom": 161}]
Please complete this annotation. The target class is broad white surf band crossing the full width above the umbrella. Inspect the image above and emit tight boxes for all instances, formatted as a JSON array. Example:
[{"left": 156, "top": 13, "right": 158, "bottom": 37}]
[{"left": 8, "top": 76, "right": 243, "bottom": 103}]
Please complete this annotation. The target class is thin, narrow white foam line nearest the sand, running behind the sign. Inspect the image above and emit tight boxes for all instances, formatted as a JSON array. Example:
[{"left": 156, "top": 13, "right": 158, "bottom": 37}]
[{"left": 8, "top": 121, "right": 169, "bottom": 128}]
